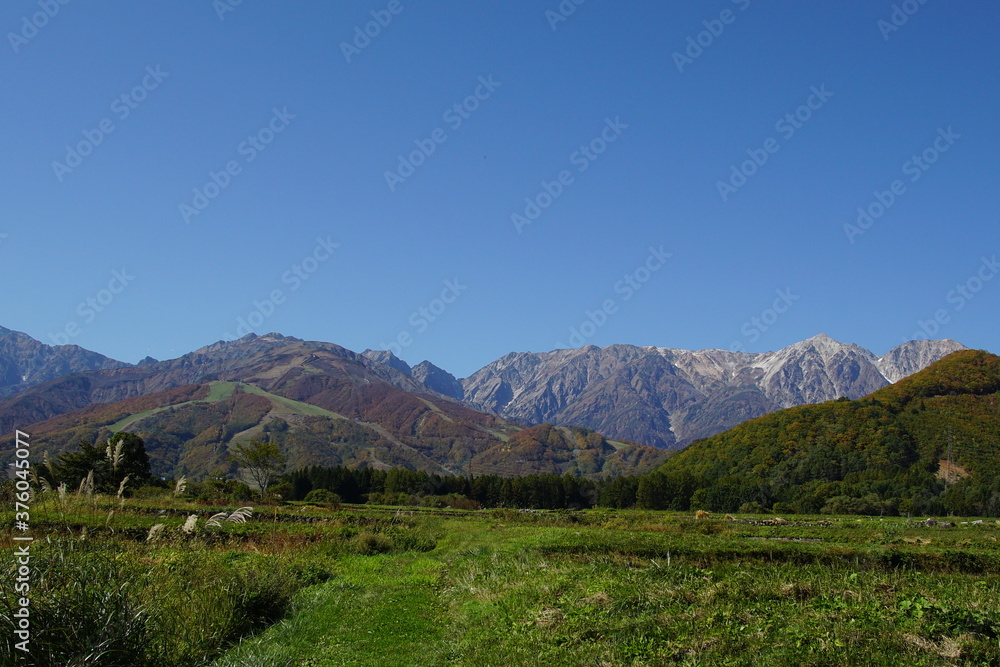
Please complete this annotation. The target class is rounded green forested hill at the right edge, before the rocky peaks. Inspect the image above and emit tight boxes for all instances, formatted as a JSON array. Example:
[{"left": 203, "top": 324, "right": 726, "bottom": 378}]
[{"left": 657, "top": 350, "right": 1000, "bottom": 514}]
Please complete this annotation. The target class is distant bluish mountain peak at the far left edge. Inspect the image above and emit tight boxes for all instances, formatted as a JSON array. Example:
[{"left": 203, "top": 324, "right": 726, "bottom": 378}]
[{"left": 0, "top": 327, "right": 129, "bottom": 396}]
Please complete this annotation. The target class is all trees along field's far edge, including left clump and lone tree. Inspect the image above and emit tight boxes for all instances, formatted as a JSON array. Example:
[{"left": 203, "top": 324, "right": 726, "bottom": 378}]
[{"left": 25, "top": 433, "right": 1000, "bottom": 516}]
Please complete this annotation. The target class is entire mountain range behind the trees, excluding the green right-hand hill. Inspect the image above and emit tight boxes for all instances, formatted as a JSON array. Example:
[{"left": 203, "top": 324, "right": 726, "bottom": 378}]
[{"left": 0, "top": 329, "right": 965, "bottom": 476}]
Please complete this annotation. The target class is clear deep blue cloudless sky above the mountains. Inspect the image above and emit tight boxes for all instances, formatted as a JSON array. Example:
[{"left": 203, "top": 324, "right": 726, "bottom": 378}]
[{"left": 0, "top": 0, "right": 1000, "bottom": 377}]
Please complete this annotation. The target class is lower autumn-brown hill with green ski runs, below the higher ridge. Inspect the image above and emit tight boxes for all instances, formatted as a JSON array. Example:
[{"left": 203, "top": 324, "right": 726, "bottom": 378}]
[{"left": 3, "top": 369, "right": 664, "bottom": 479}]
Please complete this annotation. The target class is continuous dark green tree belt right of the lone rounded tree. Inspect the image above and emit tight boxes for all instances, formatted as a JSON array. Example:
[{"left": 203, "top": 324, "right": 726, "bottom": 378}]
[{"left": 284, "top": 467, "right": 1000, "bottom": 516}]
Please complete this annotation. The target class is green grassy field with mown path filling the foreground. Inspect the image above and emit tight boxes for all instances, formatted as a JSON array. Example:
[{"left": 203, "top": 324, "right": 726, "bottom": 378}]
[{"left": 0, "top": 499, "right": 1000, "bottom": 667}]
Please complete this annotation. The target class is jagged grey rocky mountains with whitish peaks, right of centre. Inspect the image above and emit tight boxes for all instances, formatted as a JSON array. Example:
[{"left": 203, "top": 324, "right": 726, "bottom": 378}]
[{"left": 462, "top": 334, "right": 966, "bottom": 448}]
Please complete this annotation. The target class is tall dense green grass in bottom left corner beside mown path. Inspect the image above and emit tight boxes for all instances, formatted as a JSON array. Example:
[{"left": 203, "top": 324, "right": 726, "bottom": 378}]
[{"left": 0, "top": 540, "right": 303, "bottom": 667}]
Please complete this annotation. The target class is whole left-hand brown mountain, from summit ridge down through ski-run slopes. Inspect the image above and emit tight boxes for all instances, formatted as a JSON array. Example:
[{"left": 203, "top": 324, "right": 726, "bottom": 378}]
[{"left": 0, "top": 334, "right": 665, "bottom": 479}]
